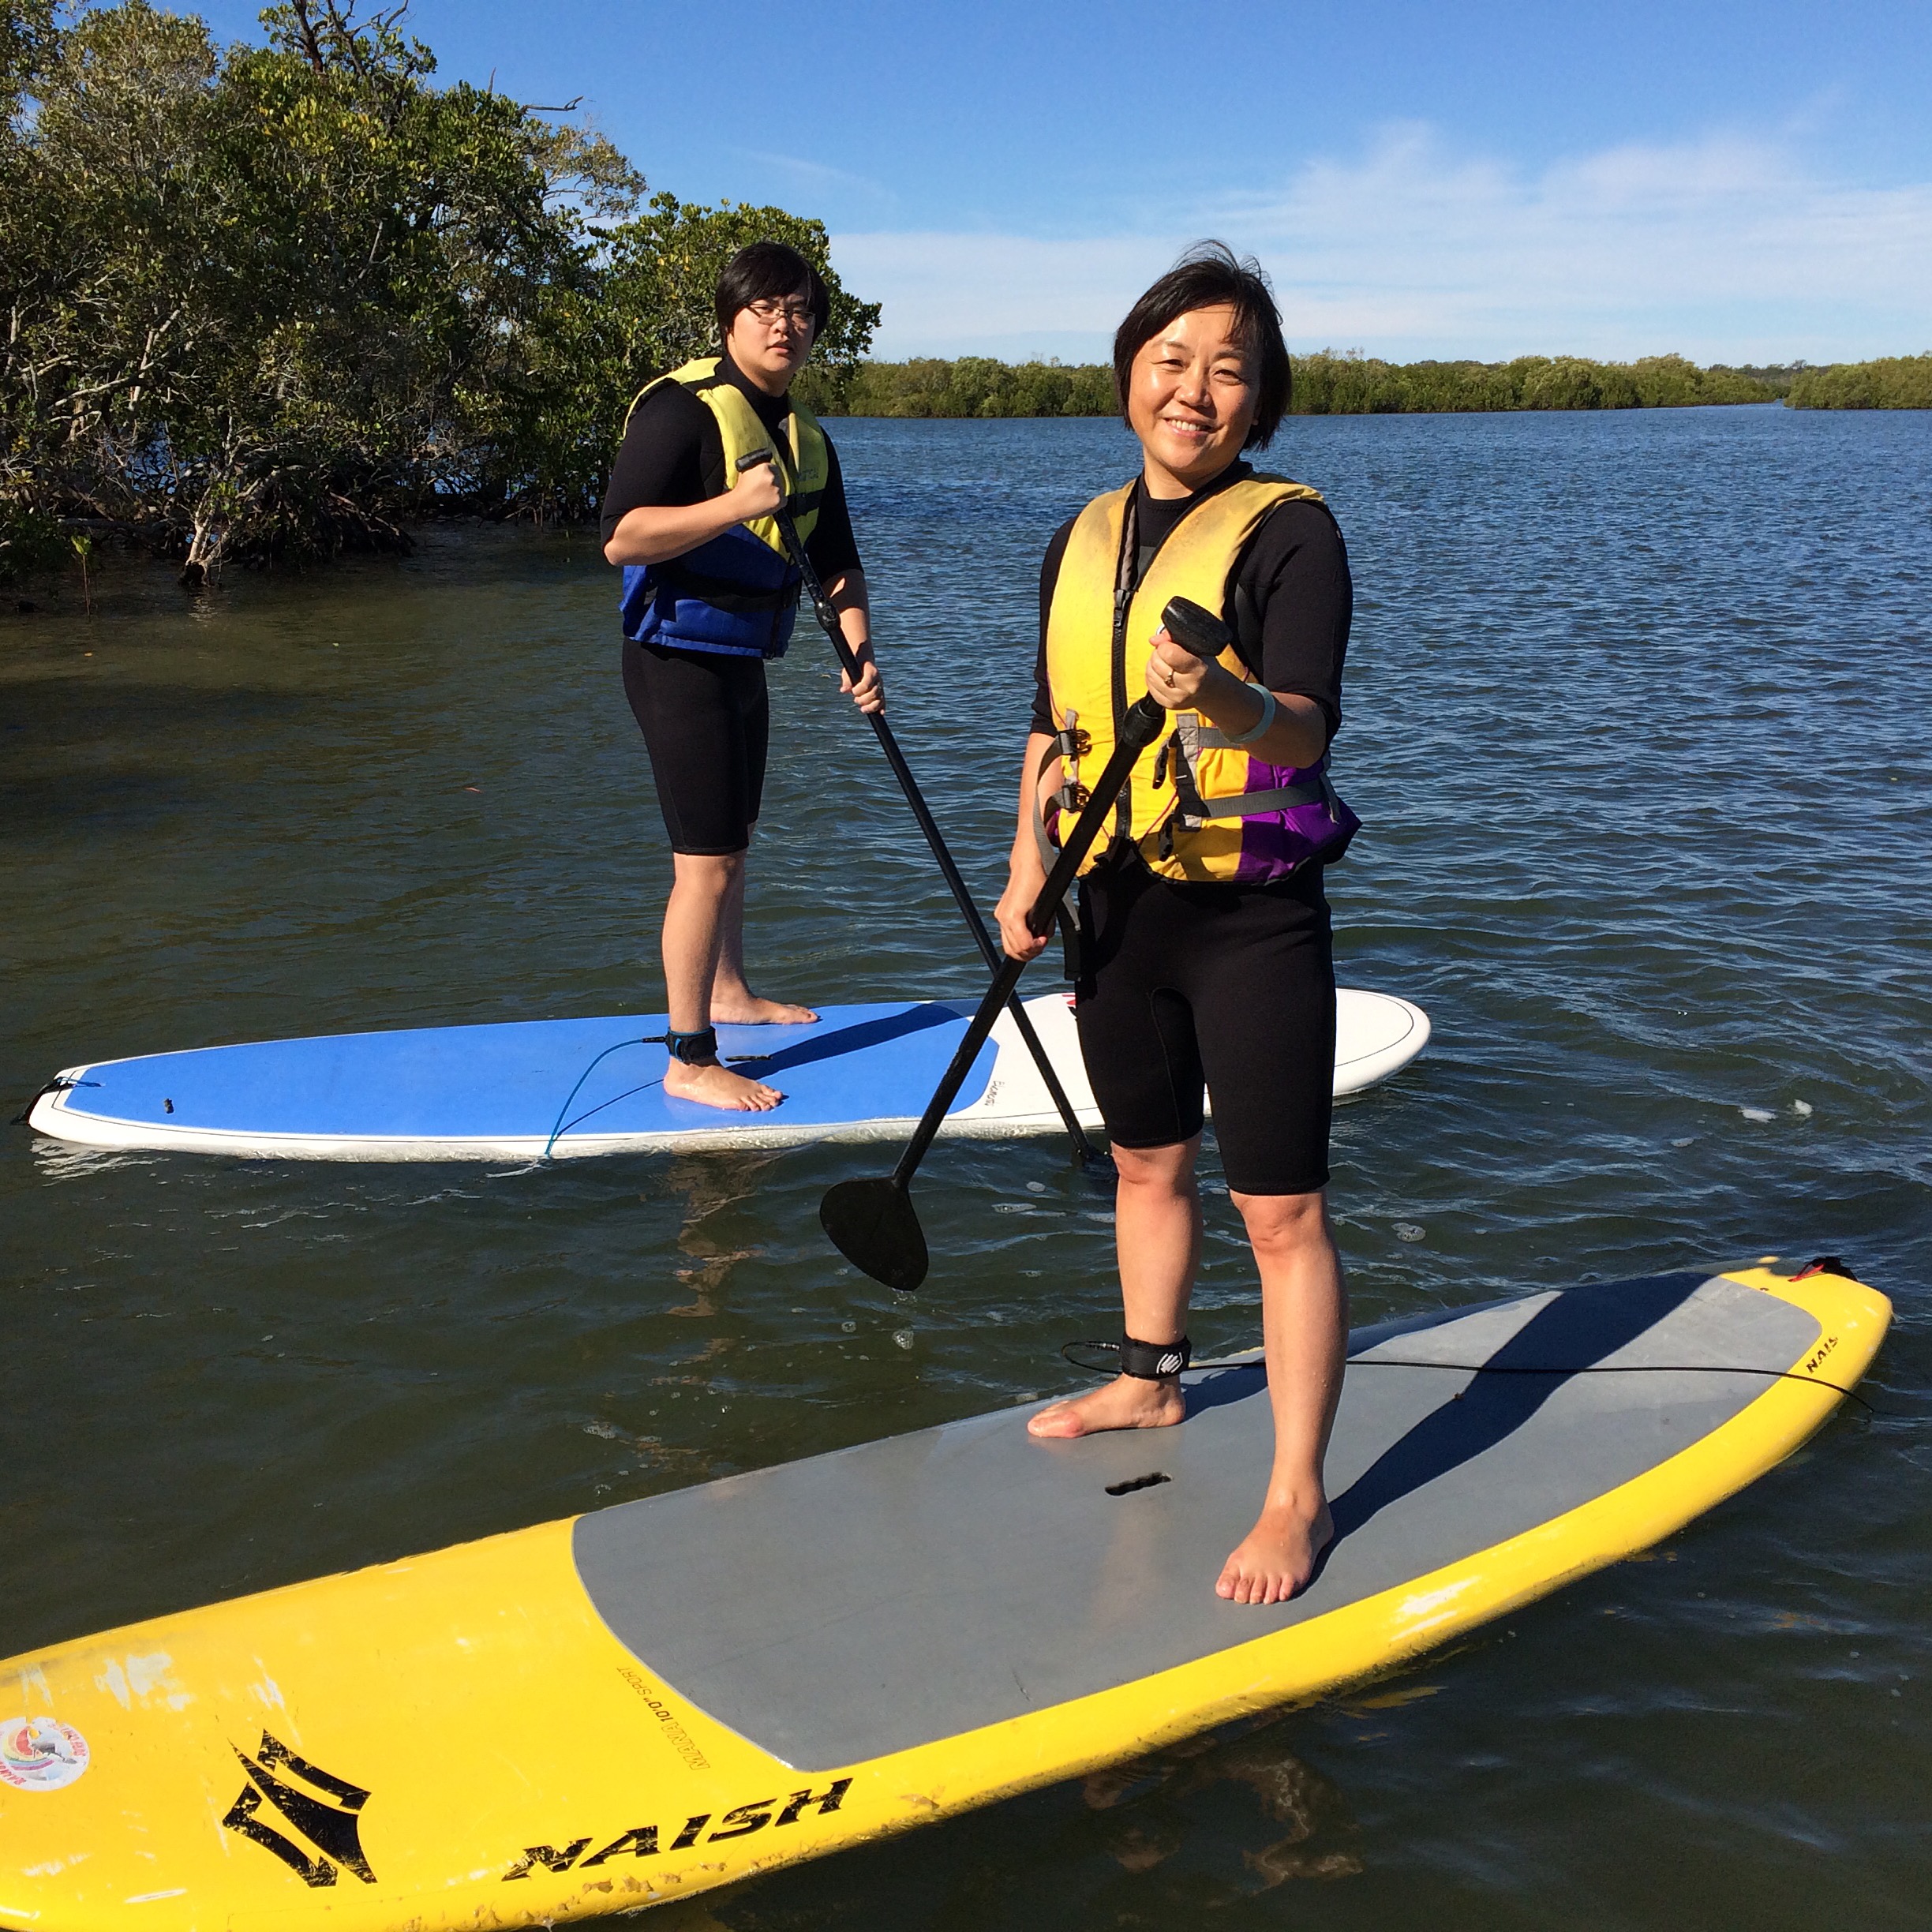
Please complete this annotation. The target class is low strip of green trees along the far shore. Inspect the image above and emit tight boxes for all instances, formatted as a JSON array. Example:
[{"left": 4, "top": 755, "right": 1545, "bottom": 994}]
[{"left": 794, "top": 350, "right": 1932, "bottom": 419}]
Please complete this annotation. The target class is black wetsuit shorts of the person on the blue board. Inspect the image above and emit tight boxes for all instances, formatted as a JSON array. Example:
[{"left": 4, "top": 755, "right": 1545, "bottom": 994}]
[{"left": 624, "top": 642, "right": 771, "bottom": 856}]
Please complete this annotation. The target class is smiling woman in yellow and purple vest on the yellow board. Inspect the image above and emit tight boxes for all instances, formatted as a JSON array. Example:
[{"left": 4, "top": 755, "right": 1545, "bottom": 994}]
[{"left": 999, "top": 243, "right": 1354, "bottom": 1604}]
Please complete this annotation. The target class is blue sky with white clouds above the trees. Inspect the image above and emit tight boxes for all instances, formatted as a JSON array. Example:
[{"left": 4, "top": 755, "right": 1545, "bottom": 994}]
[{"left": 176, "top": 0, "right": 1932, "bottom": 361}]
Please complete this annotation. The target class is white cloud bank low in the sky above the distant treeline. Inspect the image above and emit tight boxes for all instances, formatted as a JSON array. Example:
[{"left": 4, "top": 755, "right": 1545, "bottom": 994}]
[{"left": 835, "top": 125, "right": 1932, "bottom": 361}]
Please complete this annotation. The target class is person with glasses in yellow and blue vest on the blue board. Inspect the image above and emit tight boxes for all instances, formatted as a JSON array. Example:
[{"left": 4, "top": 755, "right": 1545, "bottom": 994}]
[{"left": 603, "top": 242, "right": 885, "bottom": 1113}]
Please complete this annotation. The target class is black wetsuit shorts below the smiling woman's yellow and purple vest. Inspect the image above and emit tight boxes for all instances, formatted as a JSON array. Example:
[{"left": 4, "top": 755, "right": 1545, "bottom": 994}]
[{"left": 1074, "top": 859, "right": 1335, "bottom": 1194}]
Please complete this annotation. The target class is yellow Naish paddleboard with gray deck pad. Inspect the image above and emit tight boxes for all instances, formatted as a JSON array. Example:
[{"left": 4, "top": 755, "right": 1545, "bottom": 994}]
[{"left": 0, "top": 1267, "right": 1892, "bottom": 1932}]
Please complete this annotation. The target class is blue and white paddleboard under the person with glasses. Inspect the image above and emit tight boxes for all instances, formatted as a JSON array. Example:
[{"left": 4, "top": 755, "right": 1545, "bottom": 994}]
[{"left": 29, "top": 989, "right": 1430, "bottom": 1161}]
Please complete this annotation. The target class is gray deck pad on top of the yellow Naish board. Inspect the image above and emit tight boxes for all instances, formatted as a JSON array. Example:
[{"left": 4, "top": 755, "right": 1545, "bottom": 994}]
[{"left": 574, "top": 1273, "right": 1818, "bottom": 1769}]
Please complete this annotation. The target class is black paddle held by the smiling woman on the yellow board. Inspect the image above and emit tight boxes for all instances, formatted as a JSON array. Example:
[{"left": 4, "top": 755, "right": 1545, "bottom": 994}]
[{"left": 819, "top": 597, "right": 1229, "bottom": 1290}]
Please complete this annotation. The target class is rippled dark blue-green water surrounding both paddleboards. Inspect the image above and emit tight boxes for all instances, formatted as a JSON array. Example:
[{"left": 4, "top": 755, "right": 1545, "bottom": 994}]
[{"left": 11, "top": 408, "right": 1932, "bottom": 1932}]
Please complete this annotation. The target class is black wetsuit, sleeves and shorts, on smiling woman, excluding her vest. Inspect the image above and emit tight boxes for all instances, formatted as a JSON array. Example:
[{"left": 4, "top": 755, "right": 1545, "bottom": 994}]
[{"left": 1034, "top": 477, "right": 1354, "bottom": 1194}]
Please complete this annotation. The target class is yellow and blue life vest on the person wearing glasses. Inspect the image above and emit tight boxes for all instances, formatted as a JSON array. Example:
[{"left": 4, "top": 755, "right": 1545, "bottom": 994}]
[{"left": 620, "top": 355, "right": 831, "bottom": 657}]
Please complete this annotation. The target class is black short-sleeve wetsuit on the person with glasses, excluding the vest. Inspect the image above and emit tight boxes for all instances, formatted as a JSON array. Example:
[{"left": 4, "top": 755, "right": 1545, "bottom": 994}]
[{"left": 603, "top": 355, "right": 859, "bottom": 854}]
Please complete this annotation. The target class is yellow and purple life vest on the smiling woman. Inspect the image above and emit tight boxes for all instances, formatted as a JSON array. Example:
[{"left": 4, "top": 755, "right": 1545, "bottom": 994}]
[{"left": 1047, "top": 474, "right": 1353, "bottom": 883}]
